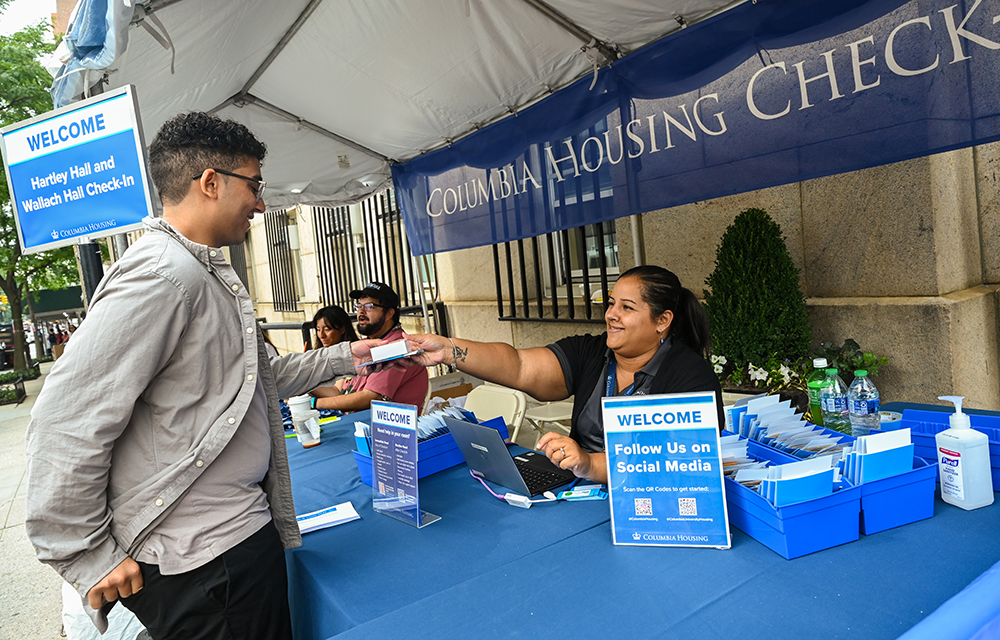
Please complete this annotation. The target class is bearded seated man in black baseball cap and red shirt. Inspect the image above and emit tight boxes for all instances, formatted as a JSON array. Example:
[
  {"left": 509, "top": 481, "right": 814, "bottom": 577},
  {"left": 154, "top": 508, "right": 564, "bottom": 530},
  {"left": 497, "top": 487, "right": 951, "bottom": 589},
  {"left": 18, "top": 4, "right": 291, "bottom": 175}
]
[{"left": 312, "top": 282, "right": 429, "bottom": 413}]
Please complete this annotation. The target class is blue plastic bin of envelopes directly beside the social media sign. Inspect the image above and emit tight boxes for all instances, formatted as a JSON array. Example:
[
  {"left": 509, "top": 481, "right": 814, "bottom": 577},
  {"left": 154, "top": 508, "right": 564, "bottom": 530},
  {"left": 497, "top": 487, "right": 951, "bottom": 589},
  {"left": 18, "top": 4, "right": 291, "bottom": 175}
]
[{"left": 726, "top": 440, "right": 861, "bottom": 560}]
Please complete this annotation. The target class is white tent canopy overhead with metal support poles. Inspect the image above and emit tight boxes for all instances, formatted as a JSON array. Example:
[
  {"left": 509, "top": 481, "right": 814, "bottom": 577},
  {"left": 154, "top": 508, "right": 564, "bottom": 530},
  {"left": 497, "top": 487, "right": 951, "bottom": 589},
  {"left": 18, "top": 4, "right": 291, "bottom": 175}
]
[{"left": 56, "top": 0, "right": 743, "bottom": 208}]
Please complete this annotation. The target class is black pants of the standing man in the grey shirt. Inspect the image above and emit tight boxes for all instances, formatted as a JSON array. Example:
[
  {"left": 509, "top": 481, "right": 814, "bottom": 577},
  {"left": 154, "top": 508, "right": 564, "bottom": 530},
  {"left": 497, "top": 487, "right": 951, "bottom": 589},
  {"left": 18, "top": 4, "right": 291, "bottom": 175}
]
[{"left": 121, "top": 522, "right": 292, "bottom": 640}]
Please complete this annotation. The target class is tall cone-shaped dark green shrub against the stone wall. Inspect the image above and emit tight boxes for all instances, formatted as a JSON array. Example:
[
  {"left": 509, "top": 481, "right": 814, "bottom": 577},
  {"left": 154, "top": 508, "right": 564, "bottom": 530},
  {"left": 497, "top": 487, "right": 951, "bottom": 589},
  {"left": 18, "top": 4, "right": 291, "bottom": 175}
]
[{"left": 705, "top": 209, "right": 812, "bottom": 378}]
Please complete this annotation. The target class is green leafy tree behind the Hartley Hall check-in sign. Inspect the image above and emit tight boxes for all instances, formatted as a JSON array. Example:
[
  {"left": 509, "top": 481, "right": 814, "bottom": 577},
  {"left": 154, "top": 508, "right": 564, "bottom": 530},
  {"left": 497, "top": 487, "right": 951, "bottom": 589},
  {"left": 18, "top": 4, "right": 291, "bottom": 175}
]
[{"left": 0, "top": 8, "right": 78, "bottom": 369}]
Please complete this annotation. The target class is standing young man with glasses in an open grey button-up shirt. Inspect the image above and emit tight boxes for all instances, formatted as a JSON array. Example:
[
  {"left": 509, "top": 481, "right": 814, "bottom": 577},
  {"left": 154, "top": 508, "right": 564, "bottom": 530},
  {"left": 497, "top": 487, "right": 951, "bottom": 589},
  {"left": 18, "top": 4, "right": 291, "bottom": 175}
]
[{"left": 26, "top": 113, "right": 377, "bottom": 640}]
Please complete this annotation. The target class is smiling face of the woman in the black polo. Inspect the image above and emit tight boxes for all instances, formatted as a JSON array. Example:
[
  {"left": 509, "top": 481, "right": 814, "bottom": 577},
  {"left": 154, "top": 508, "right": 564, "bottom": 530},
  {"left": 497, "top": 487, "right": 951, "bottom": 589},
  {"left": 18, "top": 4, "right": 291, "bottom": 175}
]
[{"left": 604, "top": 278, "right": 674, "bottom": 358}]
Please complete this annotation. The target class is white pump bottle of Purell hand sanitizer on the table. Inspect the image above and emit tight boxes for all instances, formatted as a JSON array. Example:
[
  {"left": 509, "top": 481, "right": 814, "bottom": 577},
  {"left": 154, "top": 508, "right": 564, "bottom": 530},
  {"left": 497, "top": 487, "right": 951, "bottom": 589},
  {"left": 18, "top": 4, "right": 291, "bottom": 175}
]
[{"left": 935, "top": 396, "right": 993, "bottom": 511}]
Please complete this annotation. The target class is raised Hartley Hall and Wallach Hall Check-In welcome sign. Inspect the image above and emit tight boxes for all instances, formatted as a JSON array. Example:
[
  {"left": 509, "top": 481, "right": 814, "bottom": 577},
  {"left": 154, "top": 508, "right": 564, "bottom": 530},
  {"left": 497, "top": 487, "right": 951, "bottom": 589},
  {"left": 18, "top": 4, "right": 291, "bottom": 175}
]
[{"left": 0, "top": 85, "right": 153, "bottom": 253}]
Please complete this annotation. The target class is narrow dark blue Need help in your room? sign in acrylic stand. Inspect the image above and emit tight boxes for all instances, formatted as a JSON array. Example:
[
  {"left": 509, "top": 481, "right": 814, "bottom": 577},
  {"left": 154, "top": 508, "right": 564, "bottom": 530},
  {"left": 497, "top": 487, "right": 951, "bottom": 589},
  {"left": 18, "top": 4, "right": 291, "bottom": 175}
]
[{"left": 371, "top": 401, "right": 440, "bottom": 529}]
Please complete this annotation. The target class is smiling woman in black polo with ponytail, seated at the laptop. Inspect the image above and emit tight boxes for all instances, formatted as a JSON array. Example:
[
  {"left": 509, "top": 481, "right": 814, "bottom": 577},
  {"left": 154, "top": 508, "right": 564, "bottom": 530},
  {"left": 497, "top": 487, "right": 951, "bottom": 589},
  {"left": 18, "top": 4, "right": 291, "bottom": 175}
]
[{"left": 410, "top": 266, "right": 724, "bottom": 483}]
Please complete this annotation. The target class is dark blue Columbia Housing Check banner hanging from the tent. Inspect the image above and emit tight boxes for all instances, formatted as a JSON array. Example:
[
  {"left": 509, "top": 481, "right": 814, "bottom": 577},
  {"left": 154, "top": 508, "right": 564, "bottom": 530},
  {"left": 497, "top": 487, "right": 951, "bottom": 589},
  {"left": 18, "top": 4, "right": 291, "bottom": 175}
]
[{"left": 393, "top": 0, "right": 1000, "bottom": 255}]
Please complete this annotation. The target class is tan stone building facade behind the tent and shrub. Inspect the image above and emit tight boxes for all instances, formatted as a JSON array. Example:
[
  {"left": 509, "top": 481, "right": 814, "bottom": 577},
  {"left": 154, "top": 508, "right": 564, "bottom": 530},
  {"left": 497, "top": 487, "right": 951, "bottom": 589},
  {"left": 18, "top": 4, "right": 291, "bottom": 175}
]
[{"left": 247, "top": 143, "right": 1000, "bottom": 409}]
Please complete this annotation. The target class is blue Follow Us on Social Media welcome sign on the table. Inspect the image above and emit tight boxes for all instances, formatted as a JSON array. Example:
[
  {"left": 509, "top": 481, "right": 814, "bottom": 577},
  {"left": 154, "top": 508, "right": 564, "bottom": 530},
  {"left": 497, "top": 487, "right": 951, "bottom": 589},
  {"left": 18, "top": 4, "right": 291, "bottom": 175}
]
[{"left": 602, "top": 392, "right": 731, "bottom": 549}]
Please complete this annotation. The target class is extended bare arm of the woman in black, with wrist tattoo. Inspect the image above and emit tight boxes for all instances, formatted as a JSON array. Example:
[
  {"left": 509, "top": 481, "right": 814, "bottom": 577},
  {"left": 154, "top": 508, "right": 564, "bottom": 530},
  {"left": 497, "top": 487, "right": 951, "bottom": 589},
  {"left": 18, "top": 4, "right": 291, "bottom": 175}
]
[{"left": 407, "top": 333, "right": 569, "bottom": 402}]
